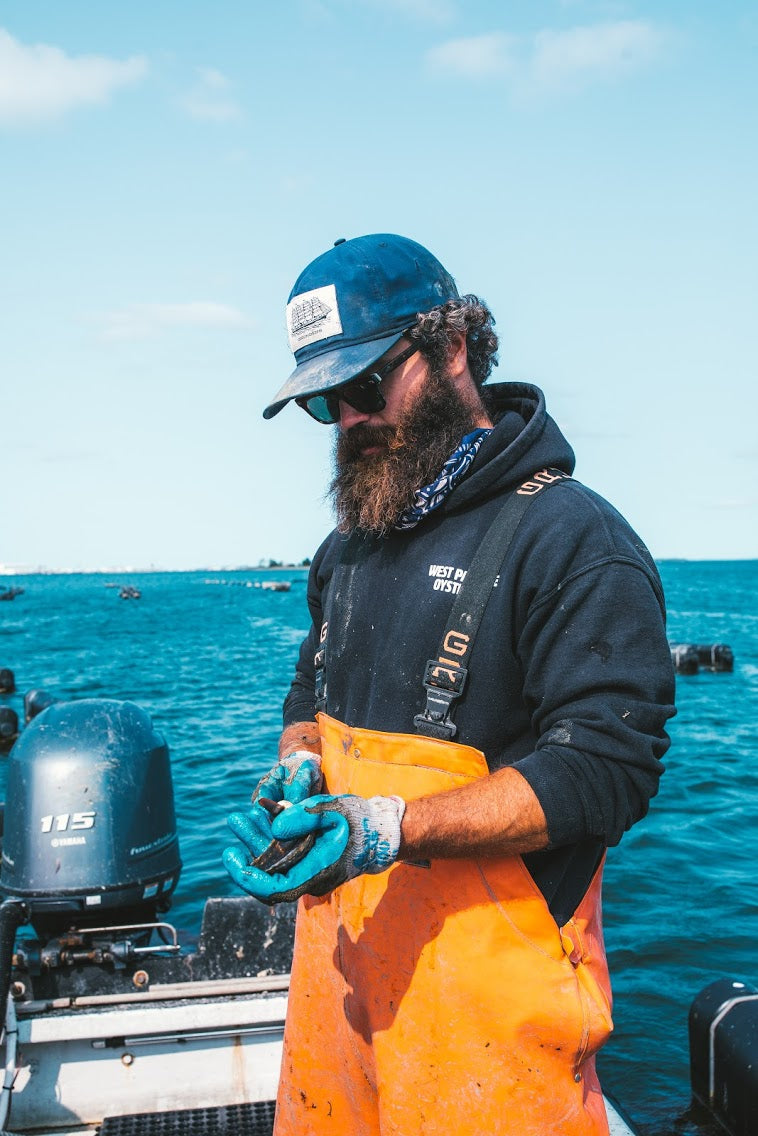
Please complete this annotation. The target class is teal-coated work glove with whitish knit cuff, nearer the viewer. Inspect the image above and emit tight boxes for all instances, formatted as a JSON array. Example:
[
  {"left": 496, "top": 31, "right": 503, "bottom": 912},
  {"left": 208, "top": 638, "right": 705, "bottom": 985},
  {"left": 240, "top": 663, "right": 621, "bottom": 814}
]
[{"left": 224, "top": 794, "right": 406, "bottom": 903}]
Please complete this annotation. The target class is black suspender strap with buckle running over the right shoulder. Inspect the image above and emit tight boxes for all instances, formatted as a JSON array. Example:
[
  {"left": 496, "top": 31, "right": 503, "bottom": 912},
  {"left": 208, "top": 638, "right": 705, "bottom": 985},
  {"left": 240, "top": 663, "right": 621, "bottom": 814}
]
[{"left": 414, "top": 469, "right": 568, "bottom": 741}]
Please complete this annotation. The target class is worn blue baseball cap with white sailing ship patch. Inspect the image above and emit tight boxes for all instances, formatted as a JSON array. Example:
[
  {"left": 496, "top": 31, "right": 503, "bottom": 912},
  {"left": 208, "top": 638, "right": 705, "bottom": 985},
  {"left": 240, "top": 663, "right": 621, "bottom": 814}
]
[{"left": 264, "top": 233, "right": 458, "bottom": 418}]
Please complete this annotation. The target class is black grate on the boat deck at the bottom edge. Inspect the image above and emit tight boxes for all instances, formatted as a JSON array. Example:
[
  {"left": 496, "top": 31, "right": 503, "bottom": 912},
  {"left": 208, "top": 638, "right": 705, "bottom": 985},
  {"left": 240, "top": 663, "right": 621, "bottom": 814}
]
[{"left": 99, "top": 1101, "right": 275, "bottom": 1136}]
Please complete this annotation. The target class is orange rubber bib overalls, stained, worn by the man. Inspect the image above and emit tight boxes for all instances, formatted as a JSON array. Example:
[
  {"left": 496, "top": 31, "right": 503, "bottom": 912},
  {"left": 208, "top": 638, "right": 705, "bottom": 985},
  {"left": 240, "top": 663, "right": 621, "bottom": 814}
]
[{"left": 274, "top": 715, "right": 611, "bottom": 1136}]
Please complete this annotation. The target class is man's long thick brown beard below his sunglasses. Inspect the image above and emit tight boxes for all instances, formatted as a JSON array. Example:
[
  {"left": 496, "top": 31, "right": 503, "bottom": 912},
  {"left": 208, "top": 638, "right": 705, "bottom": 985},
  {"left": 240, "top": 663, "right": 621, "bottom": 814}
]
[{"left": 328, "top": 374, "right": 484, "bottom": 536}]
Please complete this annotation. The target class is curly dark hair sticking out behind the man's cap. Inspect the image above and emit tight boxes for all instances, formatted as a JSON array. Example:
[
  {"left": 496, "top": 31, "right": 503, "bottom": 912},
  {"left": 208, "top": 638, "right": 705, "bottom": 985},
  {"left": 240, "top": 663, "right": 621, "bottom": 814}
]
[{"left": 408, "top": 295, "right": 498, "bottom": 387}]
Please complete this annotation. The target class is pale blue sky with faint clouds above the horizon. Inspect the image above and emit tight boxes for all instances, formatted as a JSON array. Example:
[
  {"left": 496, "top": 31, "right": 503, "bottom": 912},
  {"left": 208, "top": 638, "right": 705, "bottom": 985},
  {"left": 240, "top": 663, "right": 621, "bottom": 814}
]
[{"left": 0, "top": 0, "right": 758, "bottom": 569}]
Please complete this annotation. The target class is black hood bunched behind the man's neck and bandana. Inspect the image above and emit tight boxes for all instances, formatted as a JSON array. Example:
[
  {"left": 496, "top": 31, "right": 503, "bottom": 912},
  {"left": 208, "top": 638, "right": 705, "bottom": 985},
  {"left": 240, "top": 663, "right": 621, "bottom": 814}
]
[{"left": 448, "top": 383, "right": 576, "bottom": 511}]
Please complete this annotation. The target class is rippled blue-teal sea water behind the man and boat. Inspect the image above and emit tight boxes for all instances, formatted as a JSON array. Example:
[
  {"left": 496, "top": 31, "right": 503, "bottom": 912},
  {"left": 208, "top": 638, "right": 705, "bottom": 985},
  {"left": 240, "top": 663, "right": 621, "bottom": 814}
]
[{"left": 0, "top": 561, "right": 758, "bottom": 1136}]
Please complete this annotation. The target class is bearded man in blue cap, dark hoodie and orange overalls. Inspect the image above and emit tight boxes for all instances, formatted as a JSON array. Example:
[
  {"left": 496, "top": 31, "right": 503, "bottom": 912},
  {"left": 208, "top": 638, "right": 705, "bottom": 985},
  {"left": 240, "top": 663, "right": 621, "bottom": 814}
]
[{"left": 224, "top": 234, "right": 674, "bottom": 1136}]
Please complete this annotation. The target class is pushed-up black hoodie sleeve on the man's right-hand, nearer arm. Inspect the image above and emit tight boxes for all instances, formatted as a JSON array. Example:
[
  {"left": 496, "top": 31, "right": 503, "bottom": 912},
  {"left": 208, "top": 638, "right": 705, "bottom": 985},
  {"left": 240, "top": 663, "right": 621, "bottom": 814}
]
[{"left": 515, "top": 483, "right": 674, "bottom": 847}]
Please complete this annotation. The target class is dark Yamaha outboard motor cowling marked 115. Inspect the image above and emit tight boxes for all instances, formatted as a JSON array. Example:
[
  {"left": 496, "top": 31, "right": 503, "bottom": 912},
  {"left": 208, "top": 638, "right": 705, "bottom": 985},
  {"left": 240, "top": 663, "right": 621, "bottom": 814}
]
[{"left": 0, "top": 699, "right": 182, "bottom": 937}]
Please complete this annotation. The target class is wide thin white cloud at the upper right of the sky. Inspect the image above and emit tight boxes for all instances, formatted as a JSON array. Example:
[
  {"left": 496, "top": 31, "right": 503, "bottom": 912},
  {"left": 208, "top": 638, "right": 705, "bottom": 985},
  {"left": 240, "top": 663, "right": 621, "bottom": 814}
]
[{"left": 426, "top": 20, "right": 664, "bottom": 94}]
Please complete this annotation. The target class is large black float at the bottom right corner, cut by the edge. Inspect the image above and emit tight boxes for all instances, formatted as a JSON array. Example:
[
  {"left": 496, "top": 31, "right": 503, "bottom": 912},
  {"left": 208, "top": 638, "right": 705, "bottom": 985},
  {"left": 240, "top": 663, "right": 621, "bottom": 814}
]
[{"left": 690, "top": 978, "right": 758, "bottom": 1136}]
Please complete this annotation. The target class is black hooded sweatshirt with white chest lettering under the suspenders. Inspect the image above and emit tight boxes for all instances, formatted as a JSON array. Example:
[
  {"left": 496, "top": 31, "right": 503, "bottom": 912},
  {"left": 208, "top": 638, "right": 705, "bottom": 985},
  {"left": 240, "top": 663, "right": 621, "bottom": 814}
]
[{"left": 284, "top": 383, "right": 674, "bottom": 924}]
